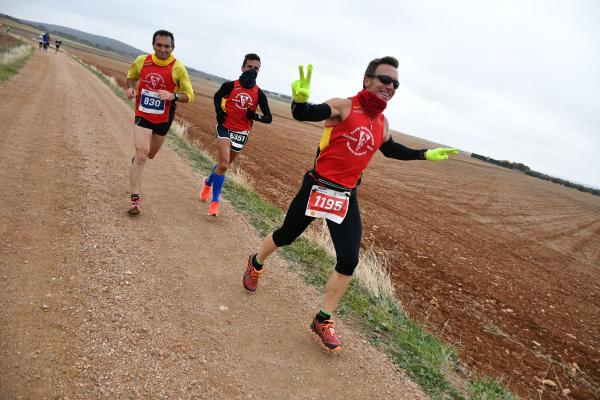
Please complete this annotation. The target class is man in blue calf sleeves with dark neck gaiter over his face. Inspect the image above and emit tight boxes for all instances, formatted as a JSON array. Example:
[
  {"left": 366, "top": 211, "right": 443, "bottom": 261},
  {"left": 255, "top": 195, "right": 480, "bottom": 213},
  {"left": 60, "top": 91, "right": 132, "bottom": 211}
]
[{"left": 200, "top": 53, "right": 273, "bottom": 217}]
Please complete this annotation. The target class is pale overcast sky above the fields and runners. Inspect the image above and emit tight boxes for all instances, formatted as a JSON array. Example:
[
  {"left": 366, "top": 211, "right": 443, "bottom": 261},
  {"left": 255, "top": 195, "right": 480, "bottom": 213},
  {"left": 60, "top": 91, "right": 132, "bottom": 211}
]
[{"left": 0, "top": 0, "right": 600, "bottom": 187}]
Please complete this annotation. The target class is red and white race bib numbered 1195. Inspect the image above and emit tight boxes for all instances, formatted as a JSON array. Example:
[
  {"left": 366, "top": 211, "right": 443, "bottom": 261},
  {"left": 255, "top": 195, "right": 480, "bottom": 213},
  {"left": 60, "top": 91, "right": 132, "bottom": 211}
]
[{"left": 305, "top": 185, "right": 350, "bottom": 224}]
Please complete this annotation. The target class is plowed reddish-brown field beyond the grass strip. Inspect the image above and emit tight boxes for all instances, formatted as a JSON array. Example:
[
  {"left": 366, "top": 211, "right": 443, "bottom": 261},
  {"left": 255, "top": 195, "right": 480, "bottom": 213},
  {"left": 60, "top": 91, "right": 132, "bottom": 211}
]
[{"left": 67, "top": 48, "right": 600, "bottom": 399}]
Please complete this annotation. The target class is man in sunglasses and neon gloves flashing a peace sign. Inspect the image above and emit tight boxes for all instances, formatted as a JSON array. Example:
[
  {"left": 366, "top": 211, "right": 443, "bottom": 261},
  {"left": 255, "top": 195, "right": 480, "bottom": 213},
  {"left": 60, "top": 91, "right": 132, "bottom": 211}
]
[{"left": 242, "top": 57, "right": 458, "bottom": 351}]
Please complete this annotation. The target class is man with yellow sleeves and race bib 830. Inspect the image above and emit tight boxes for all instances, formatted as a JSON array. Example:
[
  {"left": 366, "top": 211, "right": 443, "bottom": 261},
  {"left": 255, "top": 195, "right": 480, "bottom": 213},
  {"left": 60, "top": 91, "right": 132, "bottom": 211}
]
[{"left": 126, "top": 30, "right": 194, "bottom": 215}]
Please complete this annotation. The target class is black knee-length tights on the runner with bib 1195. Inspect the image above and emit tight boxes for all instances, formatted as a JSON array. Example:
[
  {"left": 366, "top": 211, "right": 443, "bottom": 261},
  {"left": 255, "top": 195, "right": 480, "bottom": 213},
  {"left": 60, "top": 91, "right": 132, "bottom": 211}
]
[{"left": 273, "top": 172, "right": 362, "bottom": 276}]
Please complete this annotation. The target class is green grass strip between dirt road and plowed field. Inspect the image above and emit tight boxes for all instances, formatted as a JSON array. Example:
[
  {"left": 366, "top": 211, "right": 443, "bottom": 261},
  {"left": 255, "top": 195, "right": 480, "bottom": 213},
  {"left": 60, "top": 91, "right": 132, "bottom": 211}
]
[{"left": 80, "top": 55, "right": 515, "bottom": 400}]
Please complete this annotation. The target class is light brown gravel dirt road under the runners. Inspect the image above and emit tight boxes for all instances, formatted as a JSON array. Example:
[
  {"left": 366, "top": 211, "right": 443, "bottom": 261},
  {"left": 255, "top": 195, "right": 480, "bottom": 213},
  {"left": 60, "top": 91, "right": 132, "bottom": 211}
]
[{"left": 0, "top": 52, "right": 425, "bottom": 399}]
